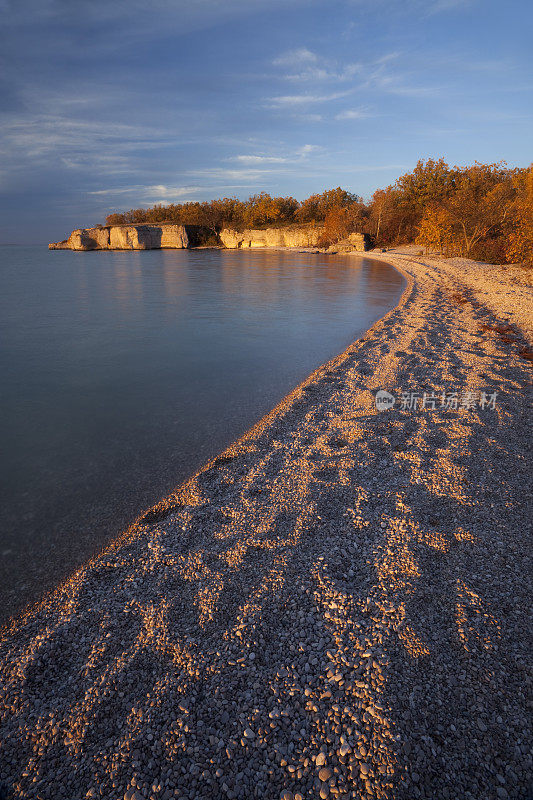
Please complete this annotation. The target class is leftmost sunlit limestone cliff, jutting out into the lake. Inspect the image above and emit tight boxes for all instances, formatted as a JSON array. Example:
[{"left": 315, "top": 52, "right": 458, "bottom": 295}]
[{"left": 48, "top": 224, "right": 200, "bottom": 250}]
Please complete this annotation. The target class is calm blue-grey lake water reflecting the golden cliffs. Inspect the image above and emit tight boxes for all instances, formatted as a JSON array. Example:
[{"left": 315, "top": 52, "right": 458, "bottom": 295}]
[{"left": 0, "top": 247, "right": 403, "bottom": 618}]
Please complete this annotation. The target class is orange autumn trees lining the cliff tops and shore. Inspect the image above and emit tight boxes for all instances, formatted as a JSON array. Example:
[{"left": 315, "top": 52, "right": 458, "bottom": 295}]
[{"left": 106, "top": 158, "right": 533, "bottom": 266}]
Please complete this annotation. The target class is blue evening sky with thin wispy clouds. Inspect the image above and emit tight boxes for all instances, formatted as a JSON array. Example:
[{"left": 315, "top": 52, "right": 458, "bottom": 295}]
[{"left": 0, "top": 0, "right": 533, "bottom": 244}]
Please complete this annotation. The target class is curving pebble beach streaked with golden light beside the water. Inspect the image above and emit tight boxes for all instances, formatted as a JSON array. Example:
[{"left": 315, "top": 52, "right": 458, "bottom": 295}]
[{"left": 0, "top": 252, "right": 532, "bottom": 800}]
